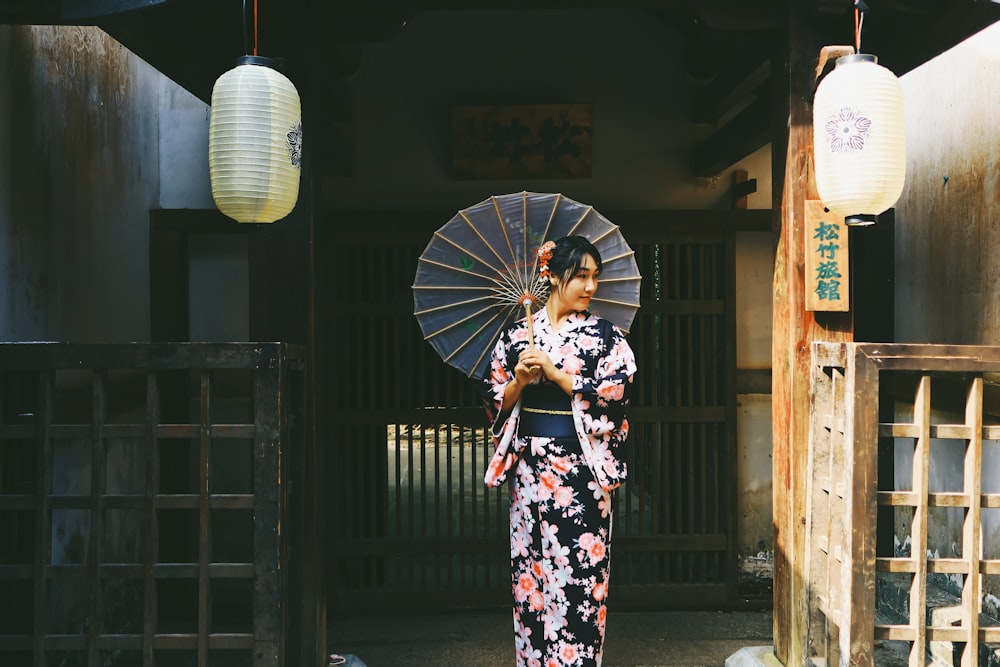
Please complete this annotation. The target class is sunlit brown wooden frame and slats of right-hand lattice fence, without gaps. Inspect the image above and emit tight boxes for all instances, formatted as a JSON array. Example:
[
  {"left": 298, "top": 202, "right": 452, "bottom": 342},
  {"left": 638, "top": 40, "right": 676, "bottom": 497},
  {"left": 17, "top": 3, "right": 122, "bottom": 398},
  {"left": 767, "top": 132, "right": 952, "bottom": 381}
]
[{"left": 804, "top": 343, "right": 1000, "bottom": 667}]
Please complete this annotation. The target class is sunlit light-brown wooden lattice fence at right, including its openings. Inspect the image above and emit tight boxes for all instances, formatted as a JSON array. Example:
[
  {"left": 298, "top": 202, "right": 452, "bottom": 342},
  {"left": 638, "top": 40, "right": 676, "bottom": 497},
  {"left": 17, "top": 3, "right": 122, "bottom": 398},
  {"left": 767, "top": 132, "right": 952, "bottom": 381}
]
[{"left": 800, "top": 343, "right": 1000, "bottom": 667}]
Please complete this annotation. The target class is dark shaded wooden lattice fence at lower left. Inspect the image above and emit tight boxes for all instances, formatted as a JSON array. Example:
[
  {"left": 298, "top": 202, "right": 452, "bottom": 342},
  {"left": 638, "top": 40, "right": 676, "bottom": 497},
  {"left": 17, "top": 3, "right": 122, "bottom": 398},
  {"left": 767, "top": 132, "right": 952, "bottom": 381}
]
[{"left": 0, "top": 343, "right": 325, "bottom": 667}]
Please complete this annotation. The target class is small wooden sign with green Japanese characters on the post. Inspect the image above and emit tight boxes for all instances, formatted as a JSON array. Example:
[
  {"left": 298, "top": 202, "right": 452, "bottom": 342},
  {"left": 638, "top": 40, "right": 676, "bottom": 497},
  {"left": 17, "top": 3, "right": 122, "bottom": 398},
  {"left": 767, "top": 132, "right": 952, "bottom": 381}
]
[{"left": 805, "top": 200, "right": 851, "bottom": 312}]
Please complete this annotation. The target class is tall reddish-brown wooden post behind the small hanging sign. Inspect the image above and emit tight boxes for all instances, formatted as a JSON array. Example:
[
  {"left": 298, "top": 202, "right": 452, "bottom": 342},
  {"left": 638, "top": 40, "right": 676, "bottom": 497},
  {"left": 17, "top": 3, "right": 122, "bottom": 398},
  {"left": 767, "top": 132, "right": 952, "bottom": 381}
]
[{"left": 771, "top": 2, "right": 853, "bottom": 665}]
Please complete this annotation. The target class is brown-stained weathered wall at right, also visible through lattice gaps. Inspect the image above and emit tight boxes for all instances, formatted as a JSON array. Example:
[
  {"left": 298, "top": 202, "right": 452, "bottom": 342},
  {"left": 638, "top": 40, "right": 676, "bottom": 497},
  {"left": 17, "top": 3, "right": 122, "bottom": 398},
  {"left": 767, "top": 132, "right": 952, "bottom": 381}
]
[{"left": 895, "top": 23, "right": 1000, "bottom": 594}]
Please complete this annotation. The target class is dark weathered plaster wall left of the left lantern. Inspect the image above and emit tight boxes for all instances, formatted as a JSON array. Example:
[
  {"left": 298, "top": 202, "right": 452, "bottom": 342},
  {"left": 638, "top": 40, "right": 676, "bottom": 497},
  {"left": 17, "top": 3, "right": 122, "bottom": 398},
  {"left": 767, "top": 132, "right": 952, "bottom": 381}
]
[{"left": 0, "top": 26, "right": 212, "bottom": 342}]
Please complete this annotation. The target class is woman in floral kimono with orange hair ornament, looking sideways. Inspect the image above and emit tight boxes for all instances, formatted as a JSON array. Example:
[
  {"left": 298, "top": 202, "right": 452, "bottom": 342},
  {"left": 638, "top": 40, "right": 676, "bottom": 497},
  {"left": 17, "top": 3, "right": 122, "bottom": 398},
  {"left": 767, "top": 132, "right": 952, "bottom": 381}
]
[{"left": 483, "top": 236, "right": 636, "bottom": 667}]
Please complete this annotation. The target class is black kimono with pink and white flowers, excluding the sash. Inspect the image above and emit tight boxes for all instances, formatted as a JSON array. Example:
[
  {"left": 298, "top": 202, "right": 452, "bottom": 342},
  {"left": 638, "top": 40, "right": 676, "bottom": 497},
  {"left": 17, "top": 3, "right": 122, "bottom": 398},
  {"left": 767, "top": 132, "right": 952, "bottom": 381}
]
[{"left": 483, "top": 309, "right": 636, "bottom": 667}]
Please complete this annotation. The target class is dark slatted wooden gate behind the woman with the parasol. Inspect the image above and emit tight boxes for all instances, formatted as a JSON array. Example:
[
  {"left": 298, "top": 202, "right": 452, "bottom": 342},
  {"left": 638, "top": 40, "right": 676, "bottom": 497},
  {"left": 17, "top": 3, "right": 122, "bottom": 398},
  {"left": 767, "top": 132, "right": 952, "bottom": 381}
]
[{"left": 317, "top": 211, "right": 767, "bottom": 614}]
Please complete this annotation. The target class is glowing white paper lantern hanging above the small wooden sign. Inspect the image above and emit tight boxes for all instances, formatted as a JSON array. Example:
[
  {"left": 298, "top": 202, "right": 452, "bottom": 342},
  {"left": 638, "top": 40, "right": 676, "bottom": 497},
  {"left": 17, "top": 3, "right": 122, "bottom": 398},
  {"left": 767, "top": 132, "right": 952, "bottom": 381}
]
[{"left": 813, "top": 54, "right": 906, "bottom": 225}]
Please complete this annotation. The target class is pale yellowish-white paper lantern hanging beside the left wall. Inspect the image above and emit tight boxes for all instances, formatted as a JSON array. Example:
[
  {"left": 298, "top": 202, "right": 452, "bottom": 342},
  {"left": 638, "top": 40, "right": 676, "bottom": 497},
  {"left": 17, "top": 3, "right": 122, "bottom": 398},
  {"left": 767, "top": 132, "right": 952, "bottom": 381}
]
[{"left": 208, "top": 56, "right": 302, "bottom": 222}]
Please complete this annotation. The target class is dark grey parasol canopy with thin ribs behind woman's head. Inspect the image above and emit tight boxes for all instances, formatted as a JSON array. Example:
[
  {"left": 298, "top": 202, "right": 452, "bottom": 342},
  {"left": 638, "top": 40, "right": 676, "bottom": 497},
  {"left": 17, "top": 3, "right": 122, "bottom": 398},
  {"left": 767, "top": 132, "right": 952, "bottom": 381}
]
[{"left": 413, "top": 192, "right": 641, "bottom": 379}]
